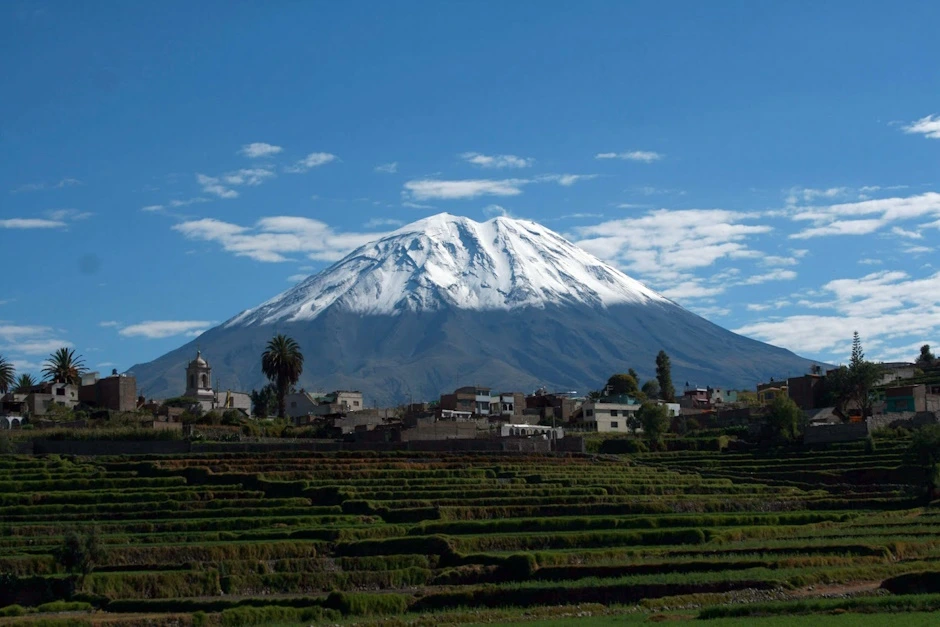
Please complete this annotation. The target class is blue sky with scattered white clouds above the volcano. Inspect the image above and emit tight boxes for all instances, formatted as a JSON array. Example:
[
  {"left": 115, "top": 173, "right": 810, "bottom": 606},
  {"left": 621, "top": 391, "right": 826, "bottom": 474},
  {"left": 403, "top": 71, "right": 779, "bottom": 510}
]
[{"left": 0, "top": 0, "right": 940, "bottom": 372}]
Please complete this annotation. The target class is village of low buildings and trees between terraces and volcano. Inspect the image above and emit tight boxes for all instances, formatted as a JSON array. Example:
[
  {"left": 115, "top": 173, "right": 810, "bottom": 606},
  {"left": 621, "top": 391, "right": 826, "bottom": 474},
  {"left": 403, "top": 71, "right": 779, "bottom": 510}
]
[{"left": 0, "top": 344, "right": 940, "bottom": 447}]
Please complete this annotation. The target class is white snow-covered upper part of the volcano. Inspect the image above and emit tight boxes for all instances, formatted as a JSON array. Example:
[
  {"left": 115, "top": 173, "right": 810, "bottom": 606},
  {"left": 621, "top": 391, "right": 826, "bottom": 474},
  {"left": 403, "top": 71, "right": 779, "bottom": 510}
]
[{"left": 226, "top": 213, "right": 665, "bottom": 326}]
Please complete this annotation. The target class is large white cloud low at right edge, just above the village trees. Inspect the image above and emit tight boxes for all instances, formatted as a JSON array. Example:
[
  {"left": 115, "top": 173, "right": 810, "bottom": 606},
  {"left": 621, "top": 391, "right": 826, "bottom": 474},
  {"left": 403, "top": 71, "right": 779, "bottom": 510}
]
[{"left": 736, "top": 271, "right": 940, "bottom": 359}]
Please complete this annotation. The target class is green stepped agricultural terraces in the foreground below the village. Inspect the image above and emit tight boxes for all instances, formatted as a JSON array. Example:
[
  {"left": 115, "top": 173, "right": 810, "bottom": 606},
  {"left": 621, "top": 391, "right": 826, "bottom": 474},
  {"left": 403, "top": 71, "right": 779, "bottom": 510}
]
[{"left": 0, "top": 438, "right": 940, "bottom": 625}]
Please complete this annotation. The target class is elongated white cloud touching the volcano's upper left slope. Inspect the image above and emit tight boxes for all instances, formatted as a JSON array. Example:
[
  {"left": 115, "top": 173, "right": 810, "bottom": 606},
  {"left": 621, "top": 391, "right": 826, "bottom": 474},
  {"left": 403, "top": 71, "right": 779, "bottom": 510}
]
[{"left": 172, "top": 216, "right": 383, "bottom": 262}]
